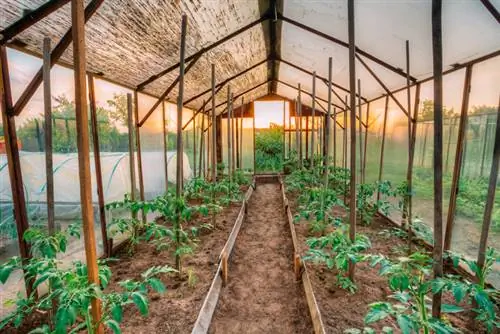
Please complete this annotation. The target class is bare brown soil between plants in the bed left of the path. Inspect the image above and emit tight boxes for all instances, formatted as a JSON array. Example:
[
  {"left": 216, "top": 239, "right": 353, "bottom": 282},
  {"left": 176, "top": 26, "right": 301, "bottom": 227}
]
[{"left": 2, "top": 198, "right": 244, "bottom": 334}]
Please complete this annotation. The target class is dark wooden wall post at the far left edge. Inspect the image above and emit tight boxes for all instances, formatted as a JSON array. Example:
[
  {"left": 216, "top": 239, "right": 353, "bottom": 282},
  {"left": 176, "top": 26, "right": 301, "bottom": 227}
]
[{"left": 0, "top": 45, "right": 36, "bottom": 296}]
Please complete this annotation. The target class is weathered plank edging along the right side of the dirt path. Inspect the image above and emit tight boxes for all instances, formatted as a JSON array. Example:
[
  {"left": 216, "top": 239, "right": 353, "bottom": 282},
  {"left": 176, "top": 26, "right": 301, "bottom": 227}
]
[{"left": 279, "top": 177, "right": 326, "bottom": 334}]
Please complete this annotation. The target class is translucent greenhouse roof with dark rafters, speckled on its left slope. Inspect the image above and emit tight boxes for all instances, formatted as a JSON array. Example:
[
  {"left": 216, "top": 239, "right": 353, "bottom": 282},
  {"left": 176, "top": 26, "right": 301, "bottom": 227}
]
[{"left": 0, "top": 0, "right": 500, "bottom": 115}]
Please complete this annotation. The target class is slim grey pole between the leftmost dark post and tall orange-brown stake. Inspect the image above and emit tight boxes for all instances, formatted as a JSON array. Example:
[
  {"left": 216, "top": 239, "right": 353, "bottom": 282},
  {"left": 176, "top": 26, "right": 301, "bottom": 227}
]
[{"left": 42, "top": 38, "right": 56, "bottom": 235}]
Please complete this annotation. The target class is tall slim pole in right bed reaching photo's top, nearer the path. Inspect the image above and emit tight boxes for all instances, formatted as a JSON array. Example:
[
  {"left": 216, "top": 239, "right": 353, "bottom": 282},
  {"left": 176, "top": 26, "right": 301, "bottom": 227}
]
[{"left": 347, "top": 0, "right": 356, "bottom": 281}]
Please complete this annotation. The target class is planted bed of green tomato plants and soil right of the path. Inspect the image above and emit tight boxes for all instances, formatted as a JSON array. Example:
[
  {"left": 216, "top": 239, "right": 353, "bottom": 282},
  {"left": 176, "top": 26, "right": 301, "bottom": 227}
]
[{"left": 284, "top": 167, "right": 500, "bottom": 333}]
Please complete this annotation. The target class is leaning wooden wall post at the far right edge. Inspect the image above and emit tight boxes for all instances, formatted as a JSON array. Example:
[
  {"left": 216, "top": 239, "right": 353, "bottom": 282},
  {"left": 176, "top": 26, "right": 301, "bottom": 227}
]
[{"left": 477, "top": 99, "right": 500, "bottom": 268}]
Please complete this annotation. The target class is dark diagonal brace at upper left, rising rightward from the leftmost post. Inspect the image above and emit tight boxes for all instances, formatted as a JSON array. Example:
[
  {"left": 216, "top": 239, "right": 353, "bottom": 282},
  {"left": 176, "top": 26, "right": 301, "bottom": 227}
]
[{"left": 12, "top": 0, "right": 104, "bottom": 116}]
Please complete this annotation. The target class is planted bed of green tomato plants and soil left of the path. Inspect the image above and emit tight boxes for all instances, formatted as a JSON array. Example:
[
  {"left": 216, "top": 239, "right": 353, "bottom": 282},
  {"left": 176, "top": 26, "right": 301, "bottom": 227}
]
[{"left": 0, "top": 171, "right": 251, "bottom": 333}]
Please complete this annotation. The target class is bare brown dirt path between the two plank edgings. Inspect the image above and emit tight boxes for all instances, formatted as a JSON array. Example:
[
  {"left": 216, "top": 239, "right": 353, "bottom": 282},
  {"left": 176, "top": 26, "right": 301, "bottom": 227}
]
[{"left": 209, "top": 184, "right": 313, "bottom": 334}]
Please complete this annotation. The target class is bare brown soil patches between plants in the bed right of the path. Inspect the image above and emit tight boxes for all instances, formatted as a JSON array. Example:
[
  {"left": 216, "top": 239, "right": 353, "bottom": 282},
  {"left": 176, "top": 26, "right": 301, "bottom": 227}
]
[{"left": 287, "top": 192, "right": 484, "bottom": 334}]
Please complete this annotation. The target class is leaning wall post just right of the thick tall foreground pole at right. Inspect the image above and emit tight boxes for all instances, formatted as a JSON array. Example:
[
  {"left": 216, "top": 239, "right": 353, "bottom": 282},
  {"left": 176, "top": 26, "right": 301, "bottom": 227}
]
[{"left": 443, "top": 65, "right": 472, "bottom": 251}]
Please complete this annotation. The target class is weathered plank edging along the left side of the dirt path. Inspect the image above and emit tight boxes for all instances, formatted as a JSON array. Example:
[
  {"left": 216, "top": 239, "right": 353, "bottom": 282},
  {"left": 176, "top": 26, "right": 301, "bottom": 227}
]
[{"left": 191, "top": 178, "right": 255, "bottom": 334}]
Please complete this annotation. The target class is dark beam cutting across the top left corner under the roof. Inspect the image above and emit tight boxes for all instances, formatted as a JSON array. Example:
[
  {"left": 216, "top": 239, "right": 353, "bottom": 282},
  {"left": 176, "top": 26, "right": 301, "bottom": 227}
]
[{"left": 0, "top": 0, "right": 69, "bottom": 45}]
